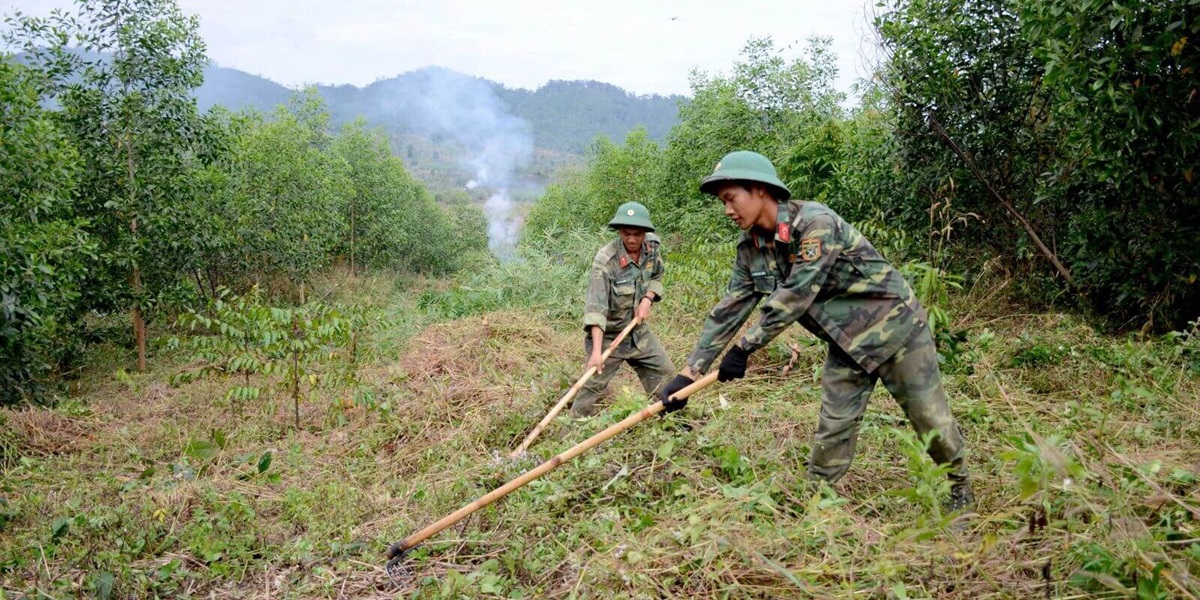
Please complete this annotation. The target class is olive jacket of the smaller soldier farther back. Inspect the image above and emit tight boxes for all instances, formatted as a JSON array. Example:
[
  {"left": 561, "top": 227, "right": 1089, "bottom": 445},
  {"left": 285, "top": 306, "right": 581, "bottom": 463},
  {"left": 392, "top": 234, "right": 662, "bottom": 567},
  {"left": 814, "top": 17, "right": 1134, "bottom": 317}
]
[{"left": 583, "top": 233, "right": 665, "bottom": 335}]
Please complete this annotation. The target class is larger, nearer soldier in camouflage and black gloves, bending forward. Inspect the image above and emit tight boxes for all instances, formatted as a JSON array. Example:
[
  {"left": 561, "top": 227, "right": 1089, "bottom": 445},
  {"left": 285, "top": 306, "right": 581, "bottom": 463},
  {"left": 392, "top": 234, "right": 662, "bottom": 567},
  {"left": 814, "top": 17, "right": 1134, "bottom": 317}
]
[{"left": 661, "top": 151, "right": 974, "bottom": 511}]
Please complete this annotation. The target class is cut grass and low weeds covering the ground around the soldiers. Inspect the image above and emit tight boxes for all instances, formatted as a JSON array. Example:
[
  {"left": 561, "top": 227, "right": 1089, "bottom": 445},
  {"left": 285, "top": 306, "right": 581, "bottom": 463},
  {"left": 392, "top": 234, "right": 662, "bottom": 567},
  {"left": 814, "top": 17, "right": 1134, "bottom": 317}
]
[{"left": 0, "top": 252, "right": 1200, "bottom": 598}]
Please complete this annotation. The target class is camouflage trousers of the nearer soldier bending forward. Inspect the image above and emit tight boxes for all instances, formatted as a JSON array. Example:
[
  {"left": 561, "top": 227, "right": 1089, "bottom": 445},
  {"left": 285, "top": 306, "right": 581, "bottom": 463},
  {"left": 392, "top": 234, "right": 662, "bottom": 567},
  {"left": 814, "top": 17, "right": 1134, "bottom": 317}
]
[{"left": 809, "top": 326, "right": 967, "bottom": 484}]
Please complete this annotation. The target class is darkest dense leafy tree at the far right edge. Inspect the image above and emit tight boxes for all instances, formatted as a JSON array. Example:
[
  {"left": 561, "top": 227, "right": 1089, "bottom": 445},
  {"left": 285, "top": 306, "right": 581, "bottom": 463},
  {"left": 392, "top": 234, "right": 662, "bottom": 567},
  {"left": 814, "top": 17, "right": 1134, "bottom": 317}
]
[{"left": 1021, "top": 0, "right": 1200, "bottom": 328}]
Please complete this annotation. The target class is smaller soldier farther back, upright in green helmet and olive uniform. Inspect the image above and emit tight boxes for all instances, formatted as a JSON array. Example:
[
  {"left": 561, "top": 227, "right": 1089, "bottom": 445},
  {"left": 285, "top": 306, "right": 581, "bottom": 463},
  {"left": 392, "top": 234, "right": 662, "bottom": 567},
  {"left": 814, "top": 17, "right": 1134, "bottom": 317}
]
[{"left": 571, "top": 202, "right": 676, "bottom": 419}]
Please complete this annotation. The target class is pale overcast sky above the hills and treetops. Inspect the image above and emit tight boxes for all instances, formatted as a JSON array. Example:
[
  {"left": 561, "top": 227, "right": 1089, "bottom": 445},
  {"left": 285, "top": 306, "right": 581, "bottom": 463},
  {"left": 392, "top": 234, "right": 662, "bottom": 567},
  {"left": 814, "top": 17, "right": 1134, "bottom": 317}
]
[{"left": 0, "top": 0, "right": 875, "bottom": 94}]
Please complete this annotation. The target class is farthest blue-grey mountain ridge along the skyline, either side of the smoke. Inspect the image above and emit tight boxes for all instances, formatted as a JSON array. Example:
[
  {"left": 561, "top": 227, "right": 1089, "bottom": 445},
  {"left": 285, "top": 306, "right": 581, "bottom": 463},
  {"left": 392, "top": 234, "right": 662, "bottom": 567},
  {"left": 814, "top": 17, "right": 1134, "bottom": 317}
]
[{"left": 196, "top": 66, "right": 683, "bottom": 154}]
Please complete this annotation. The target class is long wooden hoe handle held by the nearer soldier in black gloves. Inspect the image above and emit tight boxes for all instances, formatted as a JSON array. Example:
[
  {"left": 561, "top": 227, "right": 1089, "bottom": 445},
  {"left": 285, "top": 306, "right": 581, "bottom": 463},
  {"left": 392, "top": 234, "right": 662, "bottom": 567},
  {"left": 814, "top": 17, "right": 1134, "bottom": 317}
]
[{"left": 388, "top": 370, "right": 716, "bottom": 558}]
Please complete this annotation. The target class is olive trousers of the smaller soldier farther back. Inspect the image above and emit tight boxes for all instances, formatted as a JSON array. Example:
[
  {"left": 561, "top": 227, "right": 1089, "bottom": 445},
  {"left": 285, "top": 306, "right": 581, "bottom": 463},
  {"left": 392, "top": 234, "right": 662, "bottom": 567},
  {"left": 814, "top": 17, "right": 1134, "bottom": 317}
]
[{"left": 571, "top": 325, "right": 676, "bottom": 416}]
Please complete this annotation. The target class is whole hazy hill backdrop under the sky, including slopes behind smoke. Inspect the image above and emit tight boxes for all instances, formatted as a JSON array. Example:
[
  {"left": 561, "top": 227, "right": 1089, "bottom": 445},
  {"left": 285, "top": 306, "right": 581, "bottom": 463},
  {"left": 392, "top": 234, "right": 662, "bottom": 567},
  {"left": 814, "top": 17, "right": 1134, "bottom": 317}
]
[{"left": 16, "top": 54, "right": 684, "bottom": 190}]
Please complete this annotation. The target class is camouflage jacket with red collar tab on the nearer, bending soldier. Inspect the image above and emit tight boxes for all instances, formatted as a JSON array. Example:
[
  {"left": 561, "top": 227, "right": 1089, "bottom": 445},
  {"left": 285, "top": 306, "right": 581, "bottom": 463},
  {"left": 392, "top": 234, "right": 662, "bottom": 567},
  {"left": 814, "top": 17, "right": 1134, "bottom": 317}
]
[{"left": 688, "top": 200, "right": 926, "bottom": 373}]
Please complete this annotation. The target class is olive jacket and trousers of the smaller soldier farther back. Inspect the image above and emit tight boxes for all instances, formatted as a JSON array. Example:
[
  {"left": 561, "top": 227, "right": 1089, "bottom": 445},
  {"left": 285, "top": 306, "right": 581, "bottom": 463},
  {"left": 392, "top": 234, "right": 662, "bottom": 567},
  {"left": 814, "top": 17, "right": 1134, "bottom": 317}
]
[{"left": 571, "top": 233, "right": 676, "bottom": 416}]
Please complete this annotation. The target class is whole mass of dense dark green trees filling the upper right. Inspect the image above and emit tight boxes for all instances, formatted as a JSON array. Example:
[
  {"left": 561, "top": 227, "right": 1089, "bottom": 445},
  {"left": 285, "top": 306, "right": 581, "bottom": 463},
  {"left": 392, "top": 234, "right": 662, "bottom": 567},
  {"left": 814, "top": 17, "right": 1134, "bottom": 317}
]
[{"left": 876, "top": 0, "right": 1200, "bottom": 326}]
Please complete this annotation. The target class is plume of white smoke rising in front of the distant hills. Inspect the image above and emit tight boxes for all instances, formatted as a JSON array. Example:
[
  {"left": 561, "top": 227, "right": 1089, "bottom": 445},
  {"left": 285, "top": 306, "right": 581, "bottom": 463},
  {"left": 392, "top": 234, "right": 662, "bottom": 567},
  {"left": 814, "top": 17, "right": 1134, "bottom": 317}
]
[{"left": 369, "top": 68, "right": 533, "bottom": 258}]
